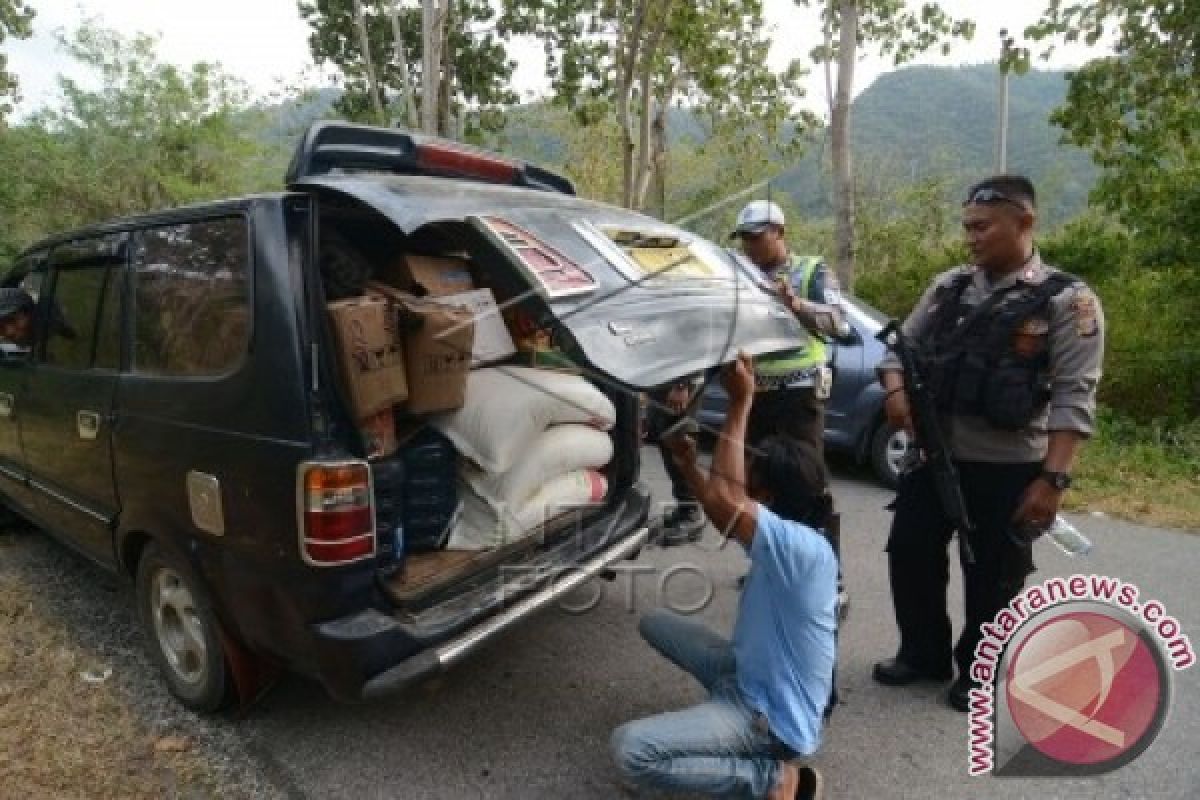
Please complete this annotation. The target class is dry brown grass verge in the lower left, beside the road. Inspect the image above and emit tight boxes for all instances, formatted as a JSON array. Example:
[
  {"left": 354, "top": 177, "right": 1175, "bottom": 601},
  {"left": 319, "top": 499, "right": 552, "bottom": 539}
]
[{"left": 0, "top": 534, "right": 220, "bottom": 800}]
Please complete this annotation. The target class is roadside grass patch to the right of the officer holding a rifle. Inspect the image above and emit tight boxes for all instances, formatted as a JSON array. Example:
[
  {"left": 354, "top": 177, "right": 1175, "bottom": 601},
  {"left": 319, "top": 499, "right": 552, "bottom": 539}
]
[{"left": 1067, "top": 411, "right": 1200, "bottom": 533}]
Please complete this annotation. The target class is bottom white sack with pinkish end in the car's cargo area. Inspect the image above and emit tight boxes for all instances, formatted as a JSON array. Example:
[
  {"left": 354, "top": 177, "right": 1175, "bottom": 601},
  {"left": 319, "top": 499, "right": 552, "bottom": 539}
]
[{"left": 446, "top": 470, "right": 608, "bottom": 551}]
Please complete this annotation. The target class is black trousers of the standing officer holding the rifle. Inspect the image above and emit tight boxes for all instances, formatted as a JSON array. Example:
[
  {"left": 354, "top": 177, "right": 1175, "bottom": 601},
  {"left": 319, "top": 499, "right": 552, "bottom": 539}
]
[{"left": 887, "top": 462, "right": 1042, "bottom": 675}]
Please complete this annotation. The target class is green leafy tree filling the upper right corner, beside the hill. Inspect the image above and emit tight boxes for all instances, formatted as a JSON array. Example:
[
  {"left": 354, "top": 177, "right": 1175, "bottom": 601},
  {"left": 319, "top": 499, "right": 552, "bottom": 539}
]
[{"left": 1025, "top": 0, "right": 1200, "bottom": 263}]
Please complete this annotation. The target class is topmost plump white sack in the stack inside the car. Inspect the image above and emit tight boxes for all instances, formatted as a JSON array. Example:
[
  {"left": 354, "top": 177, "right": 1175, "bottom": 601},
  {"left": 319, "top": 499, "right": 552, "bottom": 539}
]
[{"left": 430, "top": 367, "right": 617, "bottom": 475}]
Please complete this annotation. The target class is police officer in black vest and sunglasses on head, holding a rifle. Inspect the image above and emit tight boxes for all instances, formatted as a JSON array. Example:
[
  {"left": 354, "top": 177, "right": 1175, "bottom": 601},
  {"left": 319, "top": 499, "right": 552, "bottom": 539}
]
[{"left": 874, "top": 175, "right": 1104, "bottom": 711}]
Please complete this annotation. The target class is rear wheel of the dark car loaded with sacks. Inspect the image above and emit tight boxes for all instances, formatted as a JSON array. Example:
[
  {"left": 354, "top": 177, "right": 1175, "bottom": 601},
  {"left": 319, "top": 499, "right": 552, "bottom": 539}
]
[{"left": 137, "top": 543, "right": 234, "bottom": 714}]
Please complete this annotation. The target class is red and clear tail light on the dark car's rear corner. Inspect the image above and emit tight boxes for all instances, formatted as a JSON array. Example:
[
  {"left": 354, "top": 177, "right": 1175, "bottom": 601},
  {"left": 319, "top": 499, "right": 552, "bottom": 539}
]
[{"left": 298, "top": 461, "right": 376, "bottom": 566}]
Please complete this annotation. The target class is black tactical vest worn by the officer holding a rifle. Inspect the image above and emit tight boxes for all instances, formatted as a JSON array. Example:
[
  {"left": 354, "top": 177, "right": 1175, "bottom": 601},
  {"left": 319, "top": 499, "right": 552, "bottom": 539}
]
[{"left": 922, "top": 271, "right": 1079, "bottom": 431}]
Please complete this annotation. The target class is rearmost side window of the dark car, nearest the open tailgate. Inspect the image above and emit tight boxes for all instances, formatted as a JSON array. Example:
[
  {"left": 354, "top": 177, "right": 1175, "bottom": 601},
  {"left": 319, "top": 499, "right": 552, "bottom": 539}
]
[{"left": 133, "top": 217, "right": 250, "bottom": 375}]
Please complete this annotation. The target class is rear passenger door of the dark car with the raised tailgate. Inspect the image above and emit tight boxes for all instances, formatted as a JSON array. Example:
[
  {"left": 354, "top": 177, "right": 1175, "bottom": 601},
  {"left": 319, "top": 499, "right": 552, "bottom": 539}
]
[{"left": 18, "top": 234, "right": 128, "bottom": 565}]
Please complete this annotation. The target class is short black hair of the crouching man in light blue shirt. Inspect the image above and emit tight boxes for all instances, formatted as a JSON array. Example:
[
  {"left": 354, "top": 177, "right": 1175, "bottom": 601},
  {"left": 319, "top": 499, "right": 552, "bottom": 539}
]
[{"left": 749, "top": 435, "right": 833, "bottom": 529}]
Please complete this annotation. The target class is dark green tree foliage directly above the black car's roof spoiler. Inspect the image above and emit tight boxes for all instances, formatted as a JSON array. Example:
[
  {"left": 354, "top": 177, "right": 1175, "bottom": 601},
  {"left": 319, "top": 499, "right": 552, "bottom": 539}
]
[{"left": 298, "top": 0, "right": 517, "bottom": 136}]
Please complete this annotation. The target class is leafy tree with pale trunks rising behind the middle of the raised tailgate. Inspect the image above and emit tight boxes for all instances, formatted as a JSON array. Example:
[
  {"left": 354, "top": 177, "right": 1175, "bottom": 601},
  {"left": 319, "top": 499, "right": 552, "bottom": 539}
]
[{"left": 502, "top": 0, "right": 802, "bottom": 209}]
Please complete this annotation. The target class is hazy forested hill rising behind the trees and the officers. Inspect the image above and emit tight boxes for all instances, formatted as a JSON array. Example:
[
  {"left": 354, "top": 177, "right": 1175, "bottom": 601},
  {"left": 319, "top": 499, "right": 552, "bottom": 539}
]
[{"left": 494, "top": 64, "right": 1096, "bottom": 224}]
